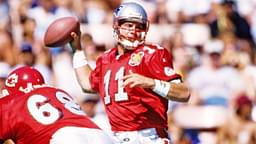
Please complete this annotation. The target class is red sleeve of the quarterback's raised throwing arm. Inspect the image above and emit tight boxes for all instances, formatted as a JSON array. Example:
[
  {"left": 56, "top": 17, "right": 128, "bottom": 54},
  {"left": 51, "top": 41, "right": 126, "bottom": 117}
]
[{"left": 89, "top": 57, "right": 102, "bottom": 92}]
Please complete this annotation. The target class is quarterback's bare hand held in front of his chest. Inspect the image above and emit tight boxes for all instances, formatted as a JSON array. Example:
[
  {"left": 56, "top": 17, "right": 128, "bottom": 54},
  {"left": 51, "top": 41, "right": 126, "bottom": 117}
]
[{"left": 123, "top": 70, "right": 155, "bottom": 88}]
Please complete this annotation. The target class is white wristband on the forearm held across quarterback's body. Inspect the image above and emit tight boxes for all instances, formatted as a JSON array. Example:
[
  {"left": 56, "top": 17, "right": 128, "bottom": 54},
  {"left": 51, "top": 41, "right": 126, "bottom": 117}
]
[{"left": 153, "top": 79, "right": 171, "bottom": 97}]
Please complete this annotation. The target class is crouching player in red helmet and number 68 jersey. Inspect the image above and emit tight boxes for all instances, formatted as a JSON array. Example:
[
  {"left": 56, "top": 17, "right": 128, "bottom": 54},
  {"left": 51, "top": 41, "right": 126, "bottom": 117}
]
[{"left": 0, "top": 66, "right": 112, "bottom": 144}]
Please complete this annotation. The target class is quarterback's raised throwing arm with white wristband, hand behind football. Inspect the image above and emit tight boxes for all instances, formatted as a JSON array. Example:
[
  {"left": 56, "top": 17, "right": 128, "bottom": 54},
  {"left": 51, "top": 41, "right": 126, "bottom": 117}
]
[{"left": 70, "top": 32, "right": 94, "bottom": 92}]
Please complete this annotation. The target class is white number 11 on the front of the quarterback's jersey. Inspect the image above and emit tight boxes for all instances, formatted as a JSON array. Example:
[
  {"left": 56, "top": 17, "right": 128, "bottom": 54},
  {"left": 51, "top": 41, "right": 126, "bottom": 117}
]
[{"left": 104, "top": 67, "right": 128, "bottom": 104}]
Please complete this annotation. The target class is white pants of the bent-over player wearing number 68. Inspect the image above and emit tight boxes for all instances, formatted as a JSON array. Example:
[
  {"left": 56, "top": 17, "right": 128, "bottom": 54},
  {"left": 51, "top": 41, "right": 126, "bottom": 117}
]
[{"left": 50, "top": 127, "right": 113, "bottom": 144}]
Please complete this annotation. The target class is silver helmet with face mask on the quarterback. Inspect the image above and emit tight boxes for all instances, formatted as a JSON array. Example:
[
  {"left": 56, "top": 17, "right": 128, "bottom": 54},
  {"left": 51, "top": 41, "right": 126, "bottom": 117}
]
[{"left": 113, "top": 2, "right": 149, "bottom": 49}]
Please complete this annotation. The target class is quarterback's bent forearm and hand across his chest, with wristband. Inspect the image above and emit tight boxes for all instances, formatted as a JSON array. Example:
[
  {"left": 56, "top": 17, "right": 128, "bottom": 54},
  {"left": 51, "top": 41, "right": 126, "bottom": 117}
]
[{"left": 123, "top": 72, "right": 190, "bottom": 102}]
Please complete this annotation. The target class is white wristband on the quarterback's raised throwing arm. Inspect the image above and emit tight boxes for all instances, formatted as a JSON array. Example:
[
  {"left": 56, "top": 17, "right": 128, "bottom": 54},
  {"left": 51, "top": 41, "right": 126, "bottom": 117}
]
[{"left": 73, "top": 51, "right": 88, "bottom": 69}]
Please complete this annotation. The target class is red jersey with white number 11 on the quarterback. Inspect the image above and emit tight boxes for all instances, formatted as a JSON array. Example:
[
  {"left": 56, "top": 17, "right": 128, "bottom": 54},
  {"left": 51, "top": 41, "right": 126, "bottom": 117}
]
[{"left": 90, "top": 45, "right": 180, "bottom": 131}]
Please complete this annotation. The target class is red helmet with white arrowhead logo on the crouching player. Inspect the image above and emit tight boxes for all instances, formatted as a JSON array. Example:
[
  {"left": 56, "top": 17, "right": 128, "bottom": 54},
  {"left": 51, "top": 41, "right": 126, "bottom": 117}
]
[{"left": 3, "top": 66, "right": 45, "bottom": 96}]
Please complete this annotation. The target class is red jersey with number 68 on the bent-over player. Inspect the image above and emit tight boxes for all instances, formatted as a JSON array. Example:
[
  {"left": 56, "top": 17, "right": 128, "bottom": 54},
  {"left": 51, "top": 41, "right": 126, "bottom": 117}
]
[{"left": 0, "top": 87, "right": 99, "bottom": 144}]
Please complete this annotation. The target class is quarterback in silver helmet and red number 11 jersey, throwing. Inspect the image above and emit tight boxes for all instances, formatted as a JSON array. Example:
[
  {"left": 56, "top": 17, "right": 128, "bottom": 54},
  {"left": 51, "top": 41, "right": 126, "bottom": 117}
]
[{"left": 71, "top": 2, "right": 190, "bottom": 144}]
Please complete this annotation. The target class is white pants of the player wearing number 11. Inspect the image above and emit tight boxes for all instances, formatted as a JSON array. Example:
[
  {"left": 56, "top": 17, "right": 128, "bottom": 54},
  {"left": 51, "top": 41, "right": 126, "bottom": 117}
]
[{"left": 113, "top": 128, "right": 170, "bottom": 144}]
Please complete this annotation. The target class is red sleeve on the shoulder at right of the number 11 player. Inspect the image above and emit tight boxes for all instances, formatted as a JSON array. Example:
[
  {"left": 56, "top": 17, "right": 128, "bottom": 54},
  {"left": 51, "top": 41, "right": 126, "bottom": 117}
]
[{"left": 147, "top": 48, "right": 181, "bottom": 81}]
